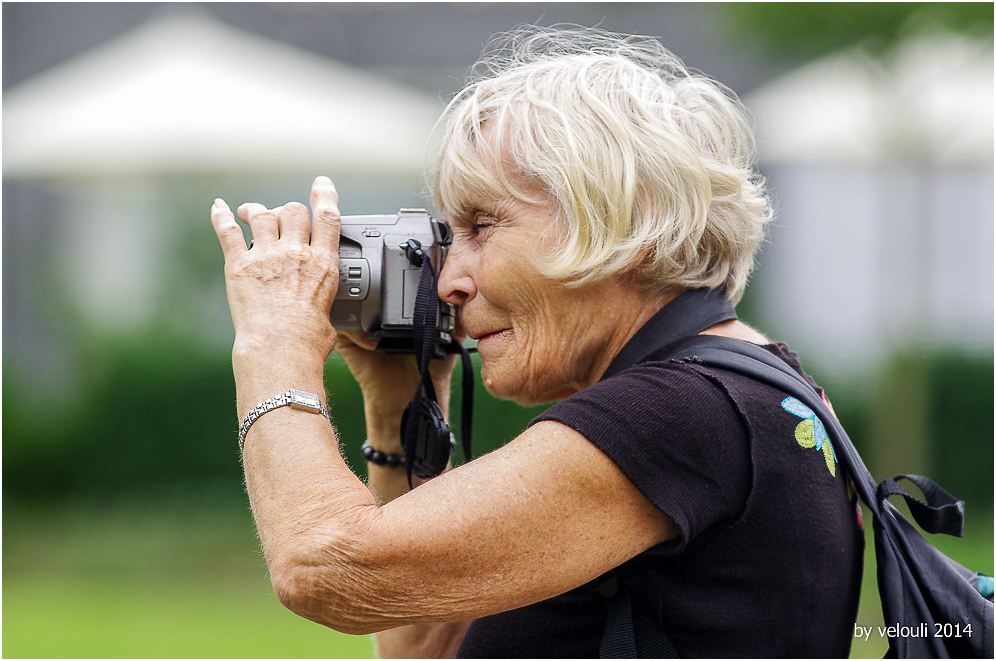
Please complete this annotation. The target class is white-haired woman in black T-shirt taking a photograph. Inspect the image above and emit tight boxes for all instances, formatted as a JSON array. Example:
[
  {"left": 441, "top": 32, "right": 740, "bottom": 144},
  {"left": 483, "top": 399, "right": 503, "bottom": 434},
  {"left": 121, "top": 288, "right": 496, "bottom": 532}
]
[{"left": 212, "top": 30, "right": 863, "bottom": 657}]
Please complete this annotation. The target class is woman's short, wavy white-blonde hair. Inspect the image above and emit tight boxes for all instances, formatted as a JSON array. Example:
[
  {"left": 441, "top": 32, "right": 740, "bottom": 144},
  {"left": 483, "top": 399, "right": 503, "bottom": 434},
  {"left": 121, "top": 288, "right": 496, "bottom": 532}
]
[{"left": 430, "top": 27, "right": 771, "bottom": 302}]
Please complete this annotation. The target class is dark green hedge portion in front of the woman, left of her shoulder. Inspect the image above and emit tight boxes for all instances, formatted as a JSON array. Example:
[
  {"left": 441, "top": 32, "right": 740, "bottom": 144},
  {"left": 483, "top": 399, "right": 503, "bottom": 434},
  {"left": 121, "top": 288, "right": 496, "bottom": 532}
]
[{"left": 3, "top": 333, "right": 544, "bottom": 505}]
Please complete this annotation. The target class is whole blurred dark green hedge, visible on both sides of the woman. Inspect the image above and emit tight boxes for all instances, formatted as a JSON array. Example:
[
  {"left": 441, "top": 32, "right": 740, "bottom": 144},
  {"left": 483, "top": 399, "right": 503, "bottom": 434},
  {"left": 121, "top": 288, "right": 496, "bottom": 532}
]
[{"left": 3, "top": 322, "right": 994, "bottom": 504}]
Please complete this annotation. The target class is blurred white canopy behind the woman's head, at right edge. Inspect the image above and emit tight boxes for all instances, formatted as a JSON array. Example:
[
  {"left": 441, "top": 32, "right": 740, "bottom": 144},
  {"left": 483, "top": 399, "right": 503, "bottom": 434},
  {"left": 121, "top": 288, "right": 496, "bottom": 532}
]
[{"left": 745, "top": 32, "right": 993, "bottom": 165}]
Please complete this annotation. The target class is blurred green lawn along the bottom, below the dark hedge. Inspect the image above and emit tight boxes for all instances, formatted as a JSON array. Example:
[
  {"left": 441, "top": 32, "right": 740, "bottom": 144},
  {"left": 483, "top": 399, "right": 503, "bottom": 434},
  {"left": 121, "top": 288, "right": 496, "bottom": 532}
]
[{"left": 2, "top": 501, "right": 993, "bottom": 658}]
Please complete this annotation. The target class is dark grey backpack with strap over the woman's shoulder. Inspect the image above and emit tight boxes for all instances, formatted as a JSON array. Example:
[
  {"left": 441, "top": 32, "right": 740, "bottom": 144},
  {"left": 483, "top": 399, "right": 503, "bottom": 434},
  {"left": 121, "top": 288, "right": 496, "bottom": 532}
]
[{"left": 592, "top": 335, "right": 993, "bottom": 659}]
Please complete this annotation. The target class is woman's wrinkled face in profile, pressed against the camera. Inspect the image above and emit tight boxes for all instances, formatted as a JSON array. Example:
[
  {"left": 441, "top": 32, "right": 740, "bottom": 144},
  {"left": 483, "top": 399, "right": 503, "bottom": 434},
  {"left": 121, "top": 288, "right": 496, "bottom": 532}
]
[{"left": 439, "top": 183, "right": 625, "bottom": 404}]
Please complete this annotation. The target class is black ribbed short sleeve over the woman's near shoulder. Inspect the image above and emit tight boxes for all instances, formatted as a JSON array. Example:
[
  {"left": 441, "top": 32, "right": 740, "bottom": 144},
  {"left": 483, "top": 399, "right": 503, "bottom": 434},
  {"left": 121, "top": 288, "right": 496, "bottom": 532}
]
[{"left": 535, "top": 360, "right": 752, "bottom": 548}]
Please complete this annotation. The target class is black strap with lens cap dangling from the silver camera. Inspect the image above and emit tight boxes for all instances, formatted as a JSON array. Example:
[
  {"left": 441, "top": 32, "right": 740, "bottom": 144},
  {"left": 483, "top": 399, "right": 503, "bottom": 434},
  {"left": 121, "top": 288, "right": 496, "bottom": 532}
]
[{"left": 401, "top": 239, "right": 474, "bottom": 488}]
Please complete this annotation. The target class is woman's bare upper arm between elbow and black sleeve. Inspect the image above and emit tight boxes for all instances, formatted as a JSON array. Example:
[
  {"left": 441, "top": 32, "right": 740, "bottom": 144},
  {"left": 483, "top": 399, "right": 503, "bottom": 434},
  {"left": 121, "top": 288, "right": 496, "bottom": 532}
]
[{"left": 307, "top": 421, "right": 678, "bottom": 631}]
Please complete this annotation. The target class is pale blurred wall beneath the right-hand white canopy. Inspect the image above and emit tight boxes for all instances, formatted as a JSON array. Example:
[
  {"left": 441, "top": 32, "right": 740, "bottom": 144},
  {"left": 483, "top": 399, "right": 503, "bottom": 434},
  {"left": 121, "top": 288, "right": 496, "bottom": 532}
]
[{"left": 752, "top": 165, "right": 994, "bottom": 379}]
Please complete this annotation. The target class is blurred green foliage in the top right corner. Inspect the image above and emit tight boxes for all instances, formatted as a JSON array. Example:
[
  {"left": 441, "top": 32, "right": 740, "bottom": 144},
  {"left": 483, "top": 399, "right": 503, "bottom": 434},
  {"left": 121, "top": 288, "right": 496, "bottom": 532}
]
[{"left": 720, "top": 2, "right": 993, "bottom": 66}]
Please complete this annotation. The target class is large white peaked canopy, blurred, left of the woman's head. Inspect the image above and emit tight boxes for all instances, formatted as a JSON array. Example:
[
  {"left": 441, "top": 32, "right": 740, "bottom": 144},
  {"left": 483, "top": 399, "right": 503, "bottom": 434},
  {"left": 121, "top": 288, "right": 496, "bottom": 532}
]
[{"left": 3, "top": 14, "right": 442, "bottom": 177}]
